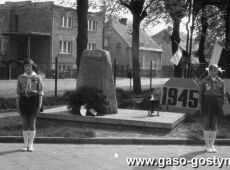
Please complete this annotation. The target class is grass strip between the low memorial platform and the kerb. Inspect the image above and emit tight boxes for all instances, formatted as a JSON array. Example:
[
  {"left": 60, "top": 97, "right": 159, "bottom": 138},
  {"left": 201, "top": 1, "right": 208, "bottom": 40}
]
[{"left": 0, "top": 117, "right": 230, "bottom": 139}]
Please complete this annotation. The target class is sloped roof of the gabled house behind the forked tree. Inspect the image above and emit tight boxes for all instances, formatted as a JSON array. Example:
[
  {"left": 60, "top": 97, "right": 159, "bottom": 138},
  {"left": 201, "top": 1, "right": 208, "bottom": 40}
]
[{"left": 112, "top": 22, "right": 163, "bottom": 52}]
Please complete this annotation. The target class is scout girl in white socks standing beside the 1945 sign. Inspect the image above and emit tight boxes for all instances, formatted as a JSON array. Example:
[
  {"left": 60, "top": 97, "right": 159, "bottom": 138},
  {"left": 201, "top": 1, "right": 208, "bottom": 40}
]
[{"left": 199, "top": 64, "right": 224, "bottom": 152}]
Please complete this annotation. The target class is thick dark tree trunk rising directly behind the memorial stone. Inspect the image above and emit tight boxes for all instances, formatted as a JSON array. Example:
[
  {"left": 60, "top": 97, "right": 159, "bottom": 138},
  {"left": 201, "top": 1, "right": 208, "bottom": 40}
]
[{"left": 76, "top": 0, "right": 88, "bottom": 74}]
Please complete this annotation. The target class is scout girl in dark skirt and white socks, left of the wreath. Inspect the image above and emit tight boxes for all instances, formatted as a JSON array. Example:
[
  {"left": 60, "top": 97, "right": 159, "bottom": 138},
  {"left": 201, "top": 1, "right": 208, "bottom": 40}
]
[{"left": 16, "top": 59, "right": 43, "bottom": 152}]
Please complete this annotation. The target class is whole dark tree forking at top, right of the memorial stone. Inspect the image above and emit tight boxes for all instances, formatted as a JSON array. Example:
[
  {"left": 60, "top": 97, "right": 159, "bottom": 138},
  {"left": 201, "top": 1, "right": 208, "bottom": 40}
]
[{"left": 120, "top": 0, "right": 154, "bottom": 94}]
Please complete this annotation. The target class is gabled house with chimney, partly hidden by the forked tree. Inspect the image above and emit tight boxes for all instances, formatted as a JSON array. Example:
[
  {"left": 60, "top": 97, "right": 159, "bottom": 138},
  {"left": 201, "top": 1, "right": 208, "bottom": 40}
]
[{"left": 104, "top": 18, "right": 163, "bottom": 75}]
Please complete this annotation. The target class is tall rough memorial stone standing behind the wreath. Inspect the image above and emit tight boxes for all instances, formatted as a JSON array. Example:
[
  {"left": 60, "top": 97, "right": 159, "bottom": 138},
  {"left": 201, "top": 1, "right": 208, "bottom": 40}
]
[{"left": 77, "top": 49, "right": 117, "bottom": 113}]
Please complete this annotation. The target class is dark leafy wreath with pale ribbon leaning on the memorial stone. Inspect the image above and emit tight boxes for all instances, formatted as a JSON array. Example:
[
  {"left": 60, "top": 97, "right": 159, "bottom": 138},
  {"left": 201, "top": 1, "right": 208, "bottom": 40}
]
[{"left": 68, "top": 87, "right": 109, "bottom": 116}]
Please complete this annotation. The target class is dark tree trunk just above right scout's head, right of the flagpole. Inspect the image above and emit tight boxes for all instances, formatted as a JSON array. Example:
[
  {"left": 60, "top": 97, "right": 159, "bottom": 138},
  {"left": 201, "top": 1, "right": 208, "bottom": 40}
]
[{"left": 198, "top": 8, "right": 208, "bottom": 63}]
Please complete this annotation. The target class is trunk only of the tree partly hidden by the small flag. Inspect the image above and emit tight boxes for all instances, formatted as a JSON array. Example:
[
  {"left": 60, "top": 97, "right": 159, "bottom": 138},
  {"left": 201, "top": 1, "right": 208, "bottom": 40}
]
[{"left": 171, "top": 18, "right": 182, "bottom": 77}]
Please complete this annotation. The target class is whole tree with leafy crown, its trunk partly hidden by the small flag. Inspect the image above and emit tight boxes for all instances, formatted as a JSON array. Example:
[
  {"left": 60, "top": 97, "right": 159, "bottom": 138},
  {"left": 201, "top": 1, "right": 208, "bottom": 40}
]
[{"left": 145, "top": 0, "right": 190, "bottom": 77}]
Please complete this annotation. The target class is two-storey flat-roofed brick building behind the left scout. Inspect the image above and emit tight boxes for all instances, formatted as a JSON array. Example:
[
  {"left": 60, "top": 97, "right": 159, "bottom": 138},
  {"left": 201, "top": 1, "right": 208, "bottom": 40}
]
[{"left": 0, "top": 1, "right": 103, "bottom": 77}]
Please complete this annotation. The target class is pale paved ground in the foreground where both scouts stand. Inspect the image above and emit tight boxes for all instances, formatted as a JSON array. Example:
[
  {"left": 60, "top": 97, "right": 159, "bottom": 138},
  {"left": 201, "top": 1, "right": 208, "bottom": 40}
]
[{"left": 0, "top": 143, "right": 230, "bottom": 170}]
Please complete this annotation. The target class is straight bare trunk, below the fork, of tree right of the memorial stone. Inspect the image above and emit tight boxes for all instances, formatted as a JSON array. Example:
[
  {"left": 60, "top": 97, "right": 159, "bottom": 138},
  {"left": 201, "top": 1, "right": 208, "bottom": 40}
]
[{"left": 132, "top": 14, "right": 141, "bottom": 94}]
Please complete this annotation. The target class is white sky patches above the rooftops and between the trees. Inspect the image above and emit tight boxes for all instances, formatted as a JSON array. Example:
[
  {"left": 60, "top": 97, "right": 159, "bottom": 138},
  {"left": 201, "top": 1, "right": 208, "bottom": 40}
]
[{"left": 0, "top": 0, "right": 187, "bottom": 36}]
